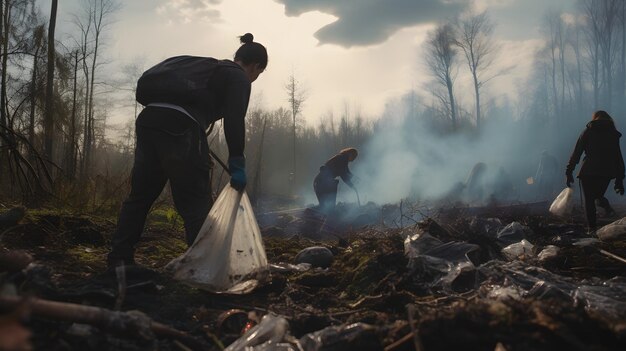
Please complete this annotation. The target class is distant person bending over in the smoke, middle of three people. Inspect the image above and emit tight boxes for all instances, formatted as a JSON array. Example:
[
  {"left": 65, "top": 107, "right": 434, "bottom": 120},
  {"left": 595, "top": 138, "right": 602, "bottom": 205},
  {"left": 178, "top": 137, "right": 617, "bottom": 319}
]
[{"left": 313, "top": 148, "right": 359, "bottom": 213}]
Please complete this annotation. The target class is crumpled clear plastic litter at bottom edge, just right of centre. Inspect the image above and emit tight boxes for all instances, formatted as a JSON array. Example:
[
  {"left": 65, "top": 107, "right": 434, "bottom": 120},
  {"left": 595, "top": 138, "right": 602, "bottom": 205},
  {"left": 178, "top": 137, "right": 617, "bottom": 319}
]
[{"left": 300, "top": 323, "right": 383, "bottom": 351}]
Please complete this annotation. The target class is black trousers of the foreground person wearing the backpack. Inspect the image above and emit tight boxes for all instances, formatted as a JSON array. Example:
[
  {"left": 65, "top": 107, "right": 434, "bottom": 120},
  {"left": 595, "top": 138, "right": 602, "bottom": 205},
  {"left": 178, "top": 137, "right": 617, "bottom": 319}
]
[{"left": 108, "top": 108, "right": 213, "bottom": 263}]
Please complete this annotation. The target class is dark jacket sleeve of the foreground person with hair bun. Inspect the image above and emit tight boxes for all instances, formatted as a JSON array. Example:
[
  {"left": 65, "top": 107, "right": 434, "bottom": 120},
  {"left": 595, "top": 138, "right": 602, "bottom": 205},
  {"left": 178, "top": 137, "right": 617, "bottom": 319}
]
[{"left": 222, "top": 69, "right": 251, "bottom": 157}]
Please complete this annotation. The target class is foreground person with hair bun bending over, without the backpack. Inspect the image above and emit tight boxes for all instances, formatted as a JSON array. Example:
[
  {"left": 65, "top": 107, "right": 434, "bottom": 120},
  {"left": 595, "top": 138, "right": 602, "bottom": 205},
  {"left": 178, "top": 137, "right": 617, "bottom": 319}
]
[{"left": 107, "top": 33, "right": 267, "bottom": 268}]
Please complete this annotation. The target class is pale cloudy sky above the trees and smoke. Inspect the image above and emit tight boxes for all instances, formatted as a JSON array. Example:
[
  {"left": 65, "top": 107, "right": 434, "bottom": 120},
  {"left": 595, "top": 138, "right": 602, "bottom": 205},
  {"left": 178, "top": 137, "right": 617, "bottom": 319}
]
[{"left": 50, "top": 0, "right": 576, "bottom": 128}]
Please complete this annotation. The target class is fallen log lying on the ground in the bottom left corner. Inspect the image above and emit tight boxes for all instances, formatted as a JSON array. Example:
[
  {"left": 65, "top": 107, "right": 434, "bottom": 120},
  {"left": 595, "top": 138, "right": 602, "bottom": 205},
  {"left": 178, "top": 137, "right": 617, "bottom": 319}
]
[{"left": 0, "top": 296, "right": 207, "bottom": 350}]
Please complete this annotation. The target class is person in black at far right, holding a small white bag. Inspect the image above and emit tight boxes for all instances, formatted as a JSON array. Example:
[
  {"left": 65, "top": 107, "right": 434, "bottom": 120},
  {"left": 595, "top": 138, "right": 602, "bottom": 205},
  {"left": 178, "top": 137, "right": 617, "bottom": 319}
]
[{"left": 566, "top": 111, "right": 624, "bottom": 232}]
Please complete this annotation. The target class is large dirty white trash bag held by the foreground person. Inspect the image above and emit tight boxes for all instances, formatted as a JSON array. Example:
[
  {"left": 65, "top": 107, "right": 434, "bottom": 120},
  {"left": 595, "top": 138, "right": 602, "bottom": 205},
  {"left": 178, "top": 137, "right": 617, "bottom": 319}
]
[{"left": 166, "top": 185, "right": 269, "bottom": 294}]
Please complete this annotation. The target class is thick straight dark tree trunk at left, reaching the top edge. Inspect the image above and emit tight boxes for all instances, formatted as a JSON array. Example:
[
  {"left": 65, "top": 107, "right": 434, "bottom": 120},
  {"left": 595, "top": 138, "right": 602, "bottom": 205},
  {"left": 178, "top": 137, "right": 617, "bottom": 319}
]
[{"left": 43, "top": 0, "right": 58, "bottom": 160}]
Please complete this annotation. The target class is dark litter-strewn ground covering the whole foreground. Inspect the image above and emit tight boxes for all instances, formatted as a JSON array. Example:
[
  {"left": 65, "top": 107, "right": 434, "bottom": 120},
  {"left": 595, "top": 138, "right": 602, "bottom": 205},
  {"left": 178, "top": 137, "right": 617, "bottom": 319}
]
[{"left": 0, "top": 204, "right": 626, "bottom": 351}]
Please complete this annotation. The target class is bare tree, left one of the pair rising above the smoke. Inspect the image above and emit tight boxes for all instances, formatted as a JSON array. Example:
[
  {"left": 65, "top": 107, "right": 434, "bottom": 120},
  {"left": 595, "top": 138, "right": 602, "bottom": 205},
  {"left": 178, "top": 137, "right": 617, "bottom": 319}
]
[{"left": 425, "top": 23, "right": 457, "bottom": 129}]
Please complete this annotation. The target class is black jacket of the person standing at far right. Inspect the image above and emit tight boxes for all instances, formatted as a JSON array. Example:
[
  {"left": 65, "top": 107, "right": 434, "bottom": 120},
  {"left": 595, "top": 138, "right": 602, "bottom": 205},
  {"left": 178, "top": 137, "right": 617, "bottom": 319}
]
[{"left": 567, "top": 119, "right": 624, "bottom": 179}]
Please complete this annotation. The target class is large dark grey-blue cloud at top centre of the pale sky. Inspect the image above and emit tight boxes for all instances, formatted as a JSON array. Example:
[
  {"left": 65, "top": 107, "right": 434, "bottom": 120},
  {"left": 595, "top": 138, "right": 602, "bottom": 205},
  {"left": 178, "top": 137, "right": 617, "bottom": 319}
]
[{"left": 276, "top": 0, "right": 469, "bottom": 47}]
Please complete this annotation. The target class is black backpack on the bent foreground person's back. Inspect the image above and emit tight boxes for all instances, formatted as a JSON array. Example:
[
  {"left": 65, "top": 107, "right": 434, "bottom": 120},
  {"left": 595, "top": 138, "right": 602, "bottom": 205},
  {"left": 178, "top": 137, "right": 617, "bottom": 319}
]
[{"left": 135, "top": 56, "right": 220, "bottom": 106}]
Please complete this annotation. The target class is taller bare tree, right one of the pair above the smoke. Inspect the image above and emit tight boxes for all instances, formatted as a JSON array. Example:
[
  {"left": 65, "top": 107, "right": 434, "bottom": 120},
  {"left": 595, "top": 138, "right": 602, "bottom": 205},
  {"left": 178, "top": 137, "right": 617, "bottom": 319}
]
[{"left": 456, "top": 11, "right": 498, "bottom": 128}]
